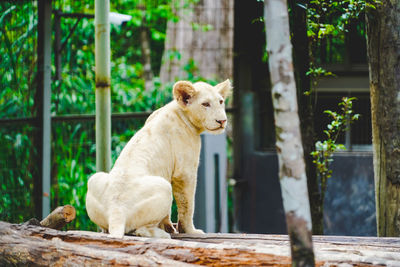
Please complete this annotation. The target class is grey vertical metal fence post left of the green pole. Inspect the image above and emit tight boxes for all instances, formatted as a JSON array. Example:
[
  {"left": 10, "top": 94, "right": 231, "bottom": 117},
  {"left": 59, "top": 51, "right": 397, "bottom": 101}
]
[{"left": 34, "top": 0, "right": 52, "bottom": 218}]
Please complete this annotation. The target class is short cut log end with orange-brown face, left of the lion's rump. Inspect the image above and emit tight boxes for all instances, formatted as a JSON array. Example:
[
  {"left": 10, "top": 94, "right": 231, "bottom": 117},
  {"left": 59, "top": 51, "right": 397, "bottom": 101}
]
[{"left": 40, "top": 205, "right": 76, "bottom": 230}]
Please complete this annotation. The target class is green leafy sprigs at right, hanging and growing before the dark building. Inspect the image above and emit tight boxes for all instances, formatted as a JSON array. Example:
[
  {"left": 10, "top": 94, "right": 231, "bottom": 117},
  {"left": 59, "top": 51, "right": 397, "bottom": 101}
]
[{"left": 304, "top": 0, "right": 380, "bottom": 197}]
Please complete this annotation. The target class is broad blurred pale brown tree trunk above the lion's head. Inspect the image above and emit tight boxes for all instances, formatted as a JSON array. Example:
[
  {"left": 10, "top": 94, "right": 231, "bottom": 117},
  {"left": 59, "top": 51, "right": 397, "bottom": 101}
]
[{"left": 160, "top": 0, "right": 233, "bottom": 83}]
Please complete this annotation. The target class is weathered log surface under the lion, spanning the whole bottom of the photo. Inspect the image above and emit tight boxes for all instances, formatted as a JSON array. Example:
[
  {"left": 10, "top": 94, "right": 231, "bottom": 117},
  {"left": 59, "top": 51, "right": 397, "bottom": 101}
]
[{"left": 0, "top": 222, "right": 400, "bottom": 266}]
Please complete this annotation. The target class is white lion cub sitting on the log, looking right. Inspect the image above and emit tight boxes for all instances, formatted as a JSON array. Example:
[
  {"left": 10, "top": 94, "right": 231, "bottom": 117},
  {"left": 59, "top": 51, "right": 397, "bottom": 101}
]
[{"left": 86, "top": 80, "right": 232, "bottom": 238}]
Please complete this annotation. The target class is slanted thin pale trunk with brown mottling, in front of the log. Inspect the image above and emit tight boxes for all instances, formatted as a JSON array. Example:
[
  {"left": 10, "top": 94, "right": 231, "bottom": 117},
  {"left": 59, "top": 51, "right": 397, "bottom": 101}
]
[{"left": 265, "top": 0, "right": 314, "bottom": 266}]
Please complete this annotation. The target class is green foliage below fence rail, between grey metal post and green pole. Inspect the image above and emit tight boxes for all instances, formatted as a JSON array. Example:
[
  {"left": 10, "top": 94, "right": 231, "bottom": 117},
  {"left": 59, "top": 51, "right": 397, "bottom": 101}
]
[{"left": 51, "top": 122, "right": 96, "bottom": 230}]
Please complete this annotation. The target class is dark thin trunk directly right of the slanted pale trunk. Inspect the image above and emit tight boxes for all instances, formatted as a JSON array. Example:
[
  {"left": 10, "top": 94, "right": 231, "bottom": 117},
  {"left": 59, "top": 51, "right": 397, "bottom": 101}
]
[{"left": 288, "top": 0, "right": 324, "bottom": 235}]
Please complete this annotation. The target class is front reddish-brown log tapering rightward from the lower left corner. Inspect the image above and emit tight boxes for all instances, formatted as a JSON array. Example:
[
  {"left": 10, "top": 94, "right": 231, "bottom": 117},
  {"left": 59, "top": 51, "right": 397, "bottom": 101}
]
[{"left": 0, "top": 222, "right": 290, "bottom": 266}]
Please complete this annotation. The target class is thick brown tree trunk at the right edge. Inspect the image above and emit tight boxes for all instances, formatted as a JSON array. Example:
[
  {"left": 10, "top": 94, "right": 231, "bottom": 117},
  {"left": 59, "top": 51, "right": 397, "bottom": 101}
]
[{"left": 366, "top": 0, "right": 400, "bottom": 239}]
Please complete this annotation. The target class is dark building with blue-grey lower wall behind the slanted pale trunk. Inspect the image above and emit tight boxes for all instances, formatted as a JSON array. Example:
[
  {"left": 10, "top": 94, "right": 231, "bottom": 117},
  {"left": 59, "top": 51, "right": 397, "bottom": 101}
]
[{"left": 233, "top": 0, "right": 376, "bottom": 235}]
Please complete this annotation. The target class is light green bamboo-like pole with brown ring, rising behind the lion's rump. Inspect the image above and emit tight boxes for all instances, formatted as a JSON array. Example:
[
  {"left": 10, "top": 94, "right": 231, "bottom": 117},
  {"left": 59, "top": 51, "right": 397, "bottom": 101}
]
[{"left": 94, "top": 0, "right": 111, "bottom": 172}]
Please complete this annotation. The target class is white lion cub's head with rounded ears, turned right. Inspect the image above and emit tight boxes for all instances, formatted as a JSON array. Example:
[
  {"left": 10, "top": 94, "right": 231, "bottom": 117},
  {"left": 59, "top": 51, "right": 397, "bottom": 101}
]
[{"left": 173, "top": 80, "right": 232, "bottom": 134}]
